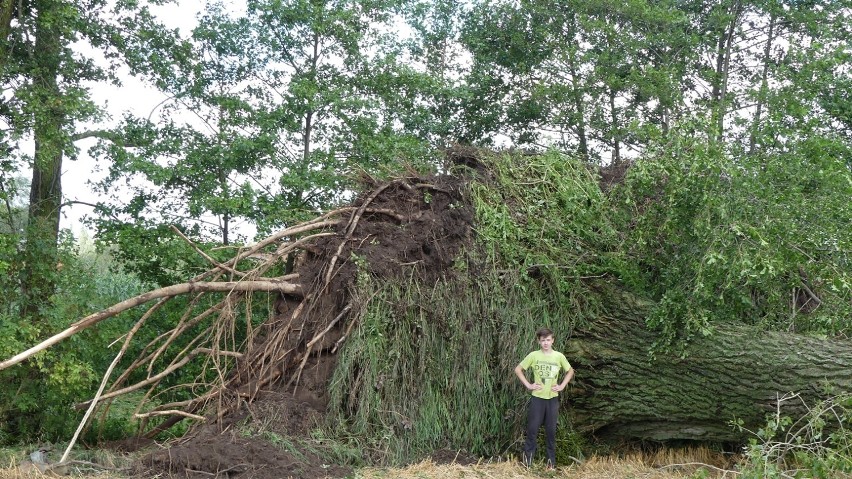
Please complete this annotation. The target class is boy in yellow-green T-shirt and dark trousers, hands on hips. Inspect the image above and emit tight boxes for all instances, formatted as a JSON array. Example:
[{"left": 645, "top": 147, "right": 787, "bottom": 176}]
[{"left": 515, "top": 328, "right": 574, "bottom": 469}]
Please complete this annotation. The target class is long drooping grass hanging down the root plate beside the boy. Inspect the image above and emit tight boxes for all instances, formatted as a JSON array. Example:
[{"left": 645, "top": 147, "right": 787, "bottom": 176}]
[{"left": 325, "top": 271, "right": 600, "bottom": 464}]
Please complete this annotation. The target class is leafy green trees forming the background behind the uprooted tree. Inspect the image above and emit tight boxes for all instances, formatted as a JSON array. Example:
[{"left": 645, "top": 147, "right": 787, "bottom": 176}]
[{"left": 0, "top": 0, "right": 852, "bottom": 441}]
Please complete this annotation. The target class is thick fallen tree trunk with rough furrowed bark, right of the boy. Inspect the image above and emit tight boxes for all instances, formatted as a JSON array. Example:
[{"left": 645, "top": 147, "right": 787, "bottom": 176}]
[{"left": 564, "top": 294, "right": 852, "bottom": 441}]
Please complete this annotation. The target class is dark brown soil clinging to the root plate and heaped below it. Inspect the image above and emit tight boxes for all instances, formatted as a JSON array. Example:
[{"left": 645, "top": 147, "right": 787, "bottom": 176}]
[{"left": 138, "top": 164, "right": 473, "bottom": 479}]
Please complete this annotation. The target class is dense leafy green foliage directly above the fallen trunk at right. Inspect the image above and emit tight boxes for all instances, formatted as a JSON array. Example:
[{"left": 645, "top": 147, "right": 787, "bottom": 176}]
[{"left": 613, "top": 122, "right": 852, "bottom": 346}]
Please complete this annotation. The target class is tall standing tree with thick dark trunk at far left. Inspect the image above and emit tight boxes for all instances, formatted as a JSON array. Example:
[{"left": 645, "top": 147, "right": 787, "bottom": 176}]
[{"left": 0, "top": 0, "right": 181, "bottom": 322}]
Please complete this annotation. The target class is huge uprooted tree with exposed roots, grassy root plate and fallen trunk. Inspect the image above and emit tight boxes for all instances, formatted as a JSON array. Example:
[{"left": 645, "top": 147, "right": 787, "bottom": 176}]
[{"left": 0, "top": 150, "right": 852, "bottom": 474}]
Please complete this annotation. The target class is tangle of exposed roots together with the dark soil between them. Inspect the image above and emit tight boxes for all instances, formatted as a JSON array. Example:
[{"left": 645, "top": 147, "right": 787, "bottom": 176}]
[{"left": 0, "top": 172, "right": 472, "bottom": 444}]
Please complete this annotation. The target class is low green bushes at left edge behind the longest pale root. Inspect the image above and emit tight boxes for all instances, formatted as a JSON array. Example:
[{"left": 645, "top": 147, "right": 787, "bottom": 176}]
[{"left": 0, "top": 233, "right": 148, "bottom": 444}]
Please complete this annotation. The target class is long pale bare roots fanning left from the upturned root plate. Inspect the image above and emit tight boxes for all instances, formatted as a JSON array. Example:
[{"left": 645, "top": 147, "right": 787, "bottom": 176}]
[{"left": 0, "top": 180, "right": 426, "bottom": 442}]
